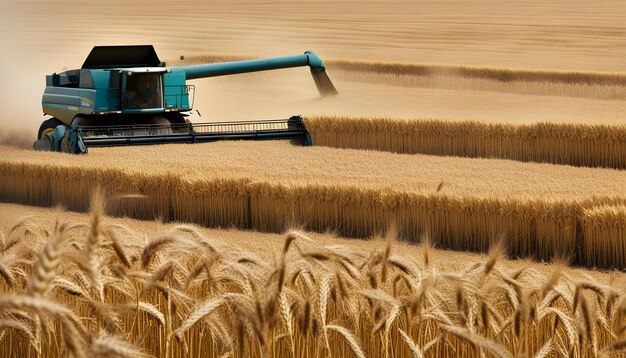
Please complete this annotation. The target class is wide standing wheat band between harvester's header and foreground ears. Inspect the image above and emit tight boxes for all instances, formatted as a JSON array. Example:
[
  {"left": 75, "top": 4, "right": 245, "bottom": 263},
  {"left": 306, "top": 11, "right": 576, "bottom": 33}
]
[{"left": 0, "top": 142, "right": 626, "bottom": 268}]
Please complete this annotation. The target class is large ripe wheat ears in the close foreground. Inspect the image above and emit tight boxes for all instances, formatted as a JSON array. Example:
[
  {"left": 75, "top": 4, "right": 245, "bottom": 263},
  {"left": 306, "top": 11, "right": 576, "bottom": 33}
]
[{"left": 0, "top": 203, "right": 626, "bottom": 357}]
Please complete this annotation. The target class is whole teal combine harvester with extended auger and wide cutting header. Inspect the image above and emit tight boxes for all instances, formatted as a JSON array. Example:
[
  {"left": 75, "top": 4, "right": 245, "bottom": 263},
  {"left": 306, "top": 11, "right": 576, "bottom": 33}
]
[{"left": 33, "top": 46, "right": 337, "bottom": 153}]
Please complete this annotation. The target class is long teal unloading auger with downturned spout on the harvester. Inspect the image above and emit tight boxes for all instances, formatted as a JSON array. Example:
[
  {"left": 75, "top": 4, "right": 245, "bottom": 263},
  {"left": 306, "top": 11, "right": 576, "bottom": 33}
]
[{"left": 171, "top": 51, "right": 337, "bottom": 96}]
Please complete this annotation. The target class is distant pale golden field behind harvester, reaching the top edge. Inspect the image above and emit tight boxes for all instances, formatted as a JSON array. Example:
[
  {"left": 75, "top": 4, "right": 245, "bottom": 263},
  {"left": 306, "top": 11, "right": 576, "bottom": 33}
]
[{"left": 2, "top": 0, "right": 626, "bottom": 71}]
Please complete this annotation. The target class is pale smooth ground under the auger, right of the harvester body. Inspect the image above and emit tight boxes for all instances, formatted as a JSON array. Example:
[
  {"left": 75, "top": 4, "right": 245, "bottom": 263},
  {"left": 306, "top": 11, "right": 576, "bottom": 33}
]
[{"left": 185, "top": 67, "right": 626, "bottom": 124}]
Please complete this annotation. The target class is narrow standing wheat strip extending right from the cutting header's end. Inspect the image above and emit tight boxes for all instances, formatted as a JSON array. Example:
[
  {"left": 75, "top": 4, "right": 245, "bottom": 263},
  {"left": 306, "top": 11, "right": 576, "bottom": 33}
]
[{"left": 306, "top": 116, "right": 626, "bottom": 169}]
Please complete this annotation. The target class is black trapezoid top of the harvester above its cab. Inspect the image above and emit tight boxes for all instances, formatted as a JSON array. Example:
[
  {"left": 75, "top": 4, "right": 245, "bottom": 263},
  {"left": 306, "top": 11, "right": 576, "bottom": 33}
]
[{"left": 81, "top": 45, "right": 161, "bottom": 69}]
